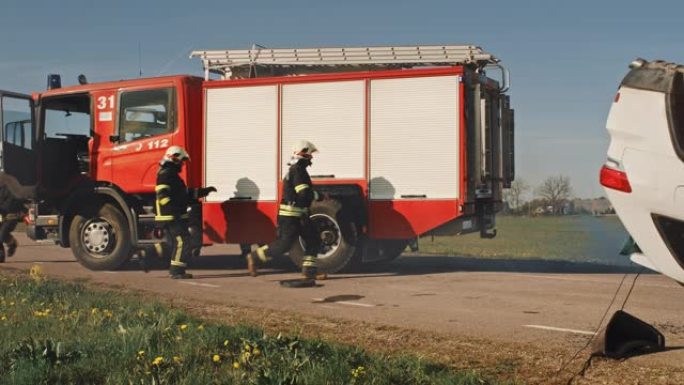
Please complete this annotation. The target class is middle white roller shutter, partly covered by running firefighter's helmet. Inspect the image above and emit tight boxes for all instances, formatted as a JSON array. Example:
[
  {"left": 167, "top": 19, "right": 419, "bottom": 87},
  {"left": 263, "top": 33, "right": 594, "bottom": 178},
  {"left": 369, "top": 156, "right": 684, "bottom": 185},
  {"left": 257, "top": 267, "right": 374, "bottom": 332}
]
[{"left": 281, "top": 80, "right": 365, "bottom": 179}]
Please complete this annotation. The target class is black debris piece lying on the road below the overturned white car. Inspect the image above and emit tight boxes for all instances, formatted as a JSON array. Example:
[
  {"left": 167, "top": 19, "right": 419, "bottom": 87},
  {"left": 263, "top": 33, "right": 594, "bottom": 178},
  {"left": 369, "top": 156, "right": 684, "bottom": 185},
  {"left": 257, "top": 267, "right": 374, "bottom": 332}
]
[{"left": 592, "top": 310, "right": 665, "bottom": 359}]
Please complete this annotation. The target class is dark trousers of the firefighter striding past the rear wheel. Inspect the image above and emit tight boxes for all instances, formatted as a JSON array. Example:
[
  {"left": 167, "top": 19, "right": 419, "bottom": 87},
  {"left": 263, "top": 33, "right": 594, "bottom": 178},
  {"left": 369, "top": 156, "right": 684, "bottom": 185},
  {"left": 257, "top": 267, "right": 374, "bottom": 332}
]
[{"left": 257, "top": 215, "right": 321, "bottom": 262}]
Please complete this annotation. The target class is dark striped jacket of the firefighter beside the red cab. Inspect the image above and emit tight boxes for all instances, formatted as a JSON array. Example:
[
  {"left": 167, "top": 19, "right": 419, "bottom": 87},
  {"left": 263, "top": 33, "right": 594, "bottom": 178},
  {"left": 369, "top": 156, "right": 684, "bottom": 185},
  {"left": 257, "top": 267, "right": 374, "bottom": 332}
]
[{"left": 155, "top": 162, "right": 188, "bottom": 222}]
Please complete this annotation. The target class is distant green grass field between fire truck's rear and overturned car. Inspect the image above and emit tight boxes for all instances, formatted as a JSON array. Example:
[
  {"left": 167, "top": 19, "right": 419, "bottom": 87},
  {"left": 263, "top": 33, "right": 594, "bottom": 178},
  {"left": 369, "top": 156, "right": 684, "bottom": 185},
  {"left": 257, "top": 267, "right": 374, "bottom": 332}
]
[{"left": 420, "top": 216, "right": 626, "bottom": 261}]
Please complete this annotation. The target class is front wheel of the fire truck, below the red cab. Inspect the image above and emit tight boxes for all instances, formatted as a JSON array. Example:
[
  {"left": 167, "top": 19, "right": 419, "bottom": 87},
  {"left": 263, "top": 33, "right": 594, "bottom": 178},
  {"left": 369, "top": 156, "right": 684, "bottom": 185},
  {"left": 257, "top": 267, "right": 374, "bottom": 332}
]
[{"left": 69, "top": 203, "right": 132, "bottom": 270}]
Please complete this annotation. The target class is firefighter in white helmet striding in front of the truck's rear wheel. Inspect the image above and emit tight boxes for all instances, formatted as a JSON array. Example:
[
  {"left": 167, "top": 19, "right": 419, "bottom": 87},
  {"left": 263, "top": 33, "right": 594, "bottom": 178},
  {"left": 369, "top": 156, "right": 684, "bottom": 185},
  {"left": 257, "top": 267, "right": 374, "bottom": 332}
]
[{"left": 247, "top": 140, "right": 320, "bottom": 279}]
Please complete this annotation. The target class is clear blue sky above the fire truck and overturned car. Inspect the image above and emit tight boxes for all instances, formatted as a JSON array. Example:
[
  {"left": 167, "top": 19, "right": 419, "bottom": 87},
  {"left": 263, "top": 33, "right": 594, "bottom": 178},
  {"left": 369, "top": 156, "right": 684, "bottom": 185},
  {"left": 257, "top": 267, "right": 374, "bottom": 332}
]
[{"left": 0, "top": 0, "right": 684, "bottom": 197}]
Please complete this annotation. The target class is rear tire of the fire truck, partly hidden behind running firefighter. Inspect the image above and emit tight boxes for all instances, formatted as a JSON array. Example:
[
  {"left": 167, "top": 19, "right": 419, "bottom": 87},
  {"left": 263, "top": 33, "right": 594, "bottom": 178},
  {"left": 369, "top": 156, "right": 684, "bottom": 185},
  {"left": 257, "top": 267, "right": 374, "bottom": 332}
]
[{"left": 290, "top": 199, "right": 356, "bottom": 273}]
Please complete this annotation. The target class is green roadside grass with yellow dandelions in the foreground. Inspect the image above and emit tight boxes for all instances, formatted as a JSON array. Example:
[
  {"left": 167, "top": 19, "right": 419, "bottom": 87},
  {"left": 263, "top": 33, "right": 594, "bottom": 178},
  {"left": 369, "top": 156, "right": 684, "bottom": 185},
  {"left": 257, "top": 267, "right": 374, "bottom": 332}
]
[{"left": 0, "top": 269, "right": 512, "bottom": 385}]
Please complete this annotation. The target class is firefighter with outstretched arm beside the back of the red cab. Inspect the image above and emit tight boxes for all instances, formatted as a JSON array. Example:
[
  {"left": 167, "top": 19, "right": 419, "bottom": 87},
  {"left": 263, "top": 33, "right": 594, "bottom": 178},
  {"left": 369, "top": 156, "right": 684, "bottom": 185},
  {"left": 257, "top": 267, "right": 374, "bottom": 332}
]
[{"left": 155, "top": 146, "right": 216, "bottom": 279}]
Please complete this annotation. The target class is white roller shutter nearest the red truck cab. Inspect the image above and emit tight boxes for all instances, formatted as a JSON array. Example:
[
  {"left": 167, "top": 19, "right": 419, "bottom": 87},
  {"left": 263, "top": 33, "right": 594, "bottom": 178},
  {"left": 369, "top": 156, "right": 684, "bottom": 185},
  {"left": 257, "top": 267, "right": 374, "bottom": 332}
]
[{"left": 204, "top": 86, "right": 278, "bottom": 202}]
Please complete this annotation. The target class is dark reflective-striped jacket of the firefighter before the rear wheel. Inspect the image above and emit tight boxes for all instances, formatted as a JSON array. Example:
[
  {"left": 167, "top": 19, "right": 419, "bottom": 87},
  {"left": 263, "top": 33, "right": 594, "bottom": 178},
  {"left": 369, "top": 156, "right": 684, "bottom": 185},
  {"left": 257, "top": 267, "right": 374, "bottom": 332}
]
[{"left": 278, "top": 159, "right": 315, "bottom": 217}]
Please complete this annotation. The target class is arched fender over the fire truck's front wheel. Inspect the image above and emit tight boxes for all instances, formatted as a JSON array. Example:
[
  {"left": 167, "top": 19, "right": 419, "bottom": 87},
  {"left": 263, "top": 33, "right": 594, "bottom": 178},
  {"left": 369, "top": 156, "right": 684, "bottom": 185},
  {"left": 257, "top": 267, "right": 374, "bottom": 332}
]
[{"left": 59, "top": 182, "right": 138, "bottom": 247}]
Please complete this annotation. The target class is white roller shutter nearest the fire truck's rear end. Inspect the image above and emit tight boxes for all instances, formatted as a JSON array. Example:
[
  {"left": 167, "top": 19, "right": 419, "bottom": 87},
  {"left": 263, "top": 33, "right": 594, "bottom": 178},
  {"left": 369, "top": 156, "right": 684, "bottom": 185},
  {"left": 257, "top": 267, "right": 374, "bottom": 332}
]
[{"left": 370, "top": 76, "right": 460, "bottom": 200}]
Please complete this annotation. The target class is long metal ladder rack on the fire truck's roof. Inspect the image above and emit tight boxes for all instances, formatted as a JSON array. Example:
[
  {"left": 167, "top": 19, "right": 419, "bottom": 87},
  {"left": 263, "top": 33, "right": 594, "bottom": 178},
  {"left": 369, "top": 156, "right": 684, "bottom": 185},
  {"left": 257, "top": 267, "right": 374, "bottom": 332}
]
[{"left": 190, "top": 45, "right": 499, "bottom": 80}]
